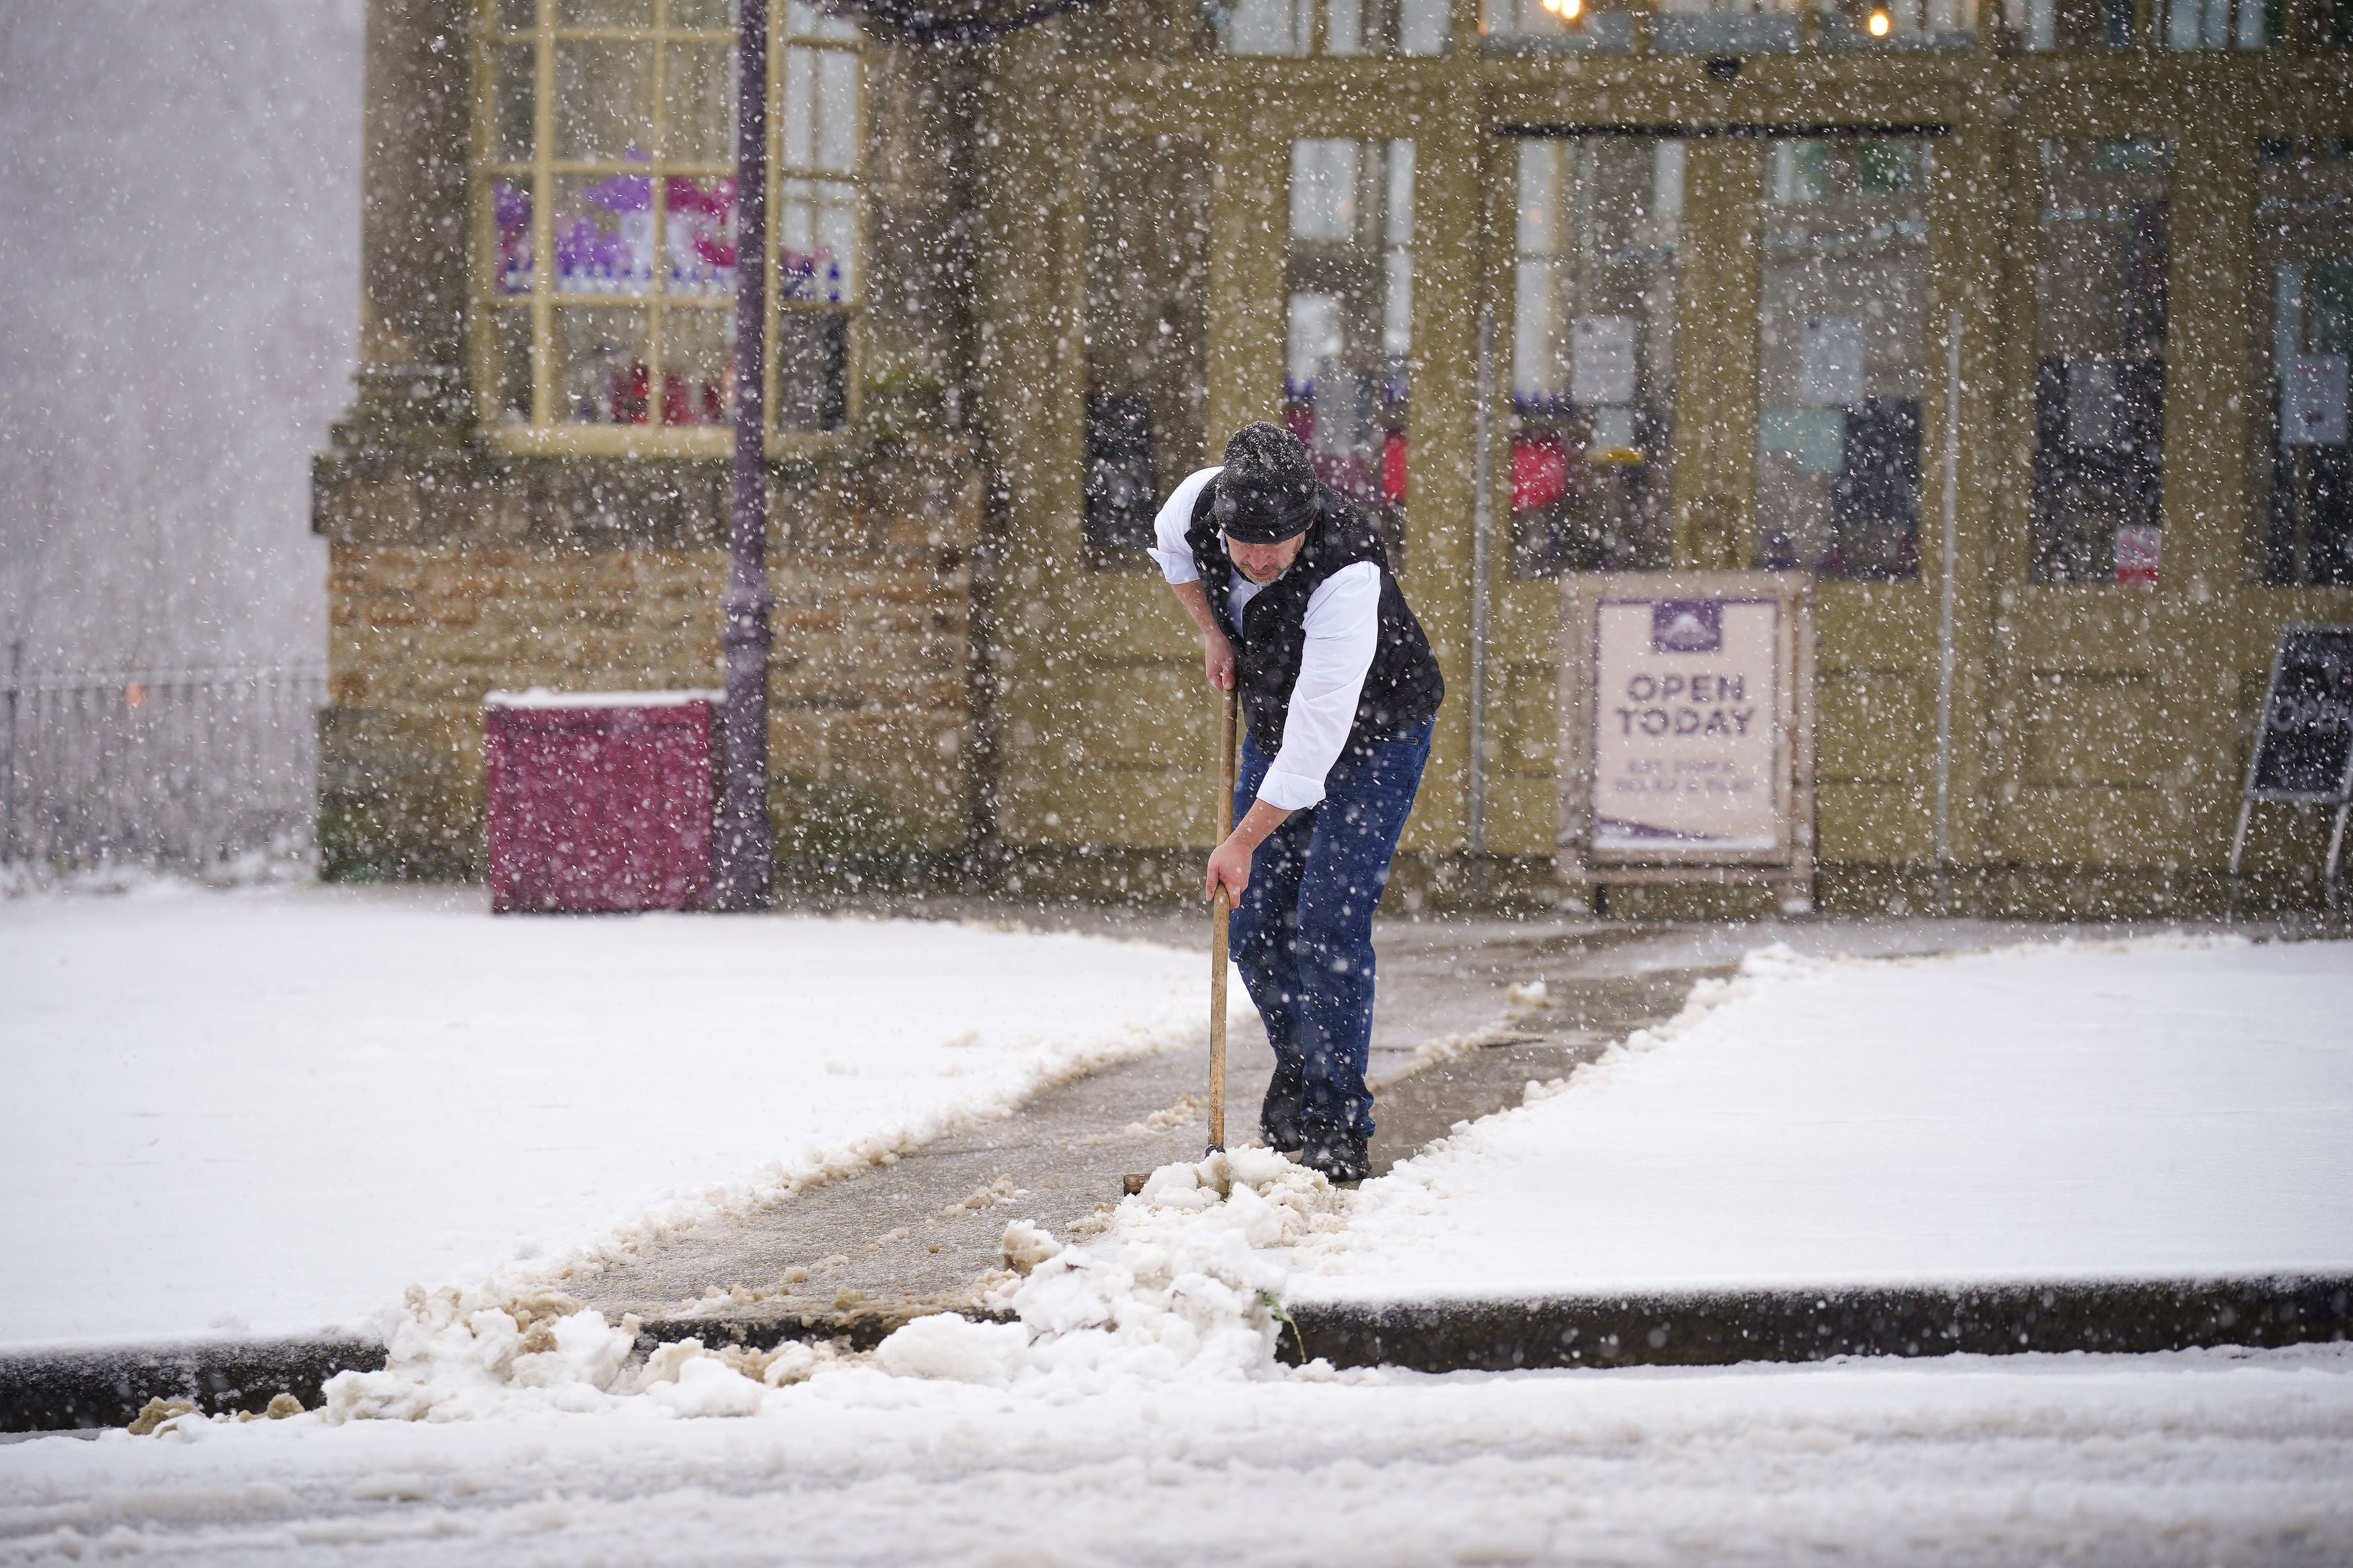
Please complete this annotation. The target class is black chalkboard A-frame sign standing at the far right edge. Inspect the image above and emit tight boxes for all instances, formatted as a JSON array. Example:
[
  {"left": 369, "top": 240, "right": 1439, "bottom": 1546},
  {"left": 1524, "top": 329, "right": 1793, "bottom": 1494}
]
[{"left": 2231, "top": 625, "right": 2353, "bottom": 907}]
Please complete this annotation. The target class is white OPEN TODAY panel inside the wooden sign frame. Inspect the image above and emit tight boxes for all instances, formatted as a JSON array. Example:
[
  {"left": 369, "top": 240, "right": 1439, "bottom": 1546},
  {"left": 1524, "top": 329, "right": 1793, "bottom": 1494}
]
[{"left": 1591, "top": 600, "right": 1784, "bottom": 851}]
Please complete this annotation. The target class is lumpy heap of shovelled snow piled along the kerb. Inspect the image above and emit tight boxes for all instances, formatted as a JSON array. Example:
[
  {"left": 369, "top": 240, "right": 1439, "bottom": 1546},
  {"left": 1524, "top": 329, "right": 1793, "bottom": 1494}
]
[{"left": 306, "top": 1149, "right": 1339, "bottom": 1425}]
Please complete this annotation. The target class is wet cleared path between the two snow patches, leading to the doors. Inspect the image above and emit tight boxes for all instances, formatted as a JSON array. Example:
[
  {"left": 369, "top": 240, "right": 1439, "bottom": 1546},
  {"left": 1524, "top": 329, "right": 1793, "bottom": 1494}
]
[{"left": 574, "top": 901, "right": 2240, "bottom": 1340}]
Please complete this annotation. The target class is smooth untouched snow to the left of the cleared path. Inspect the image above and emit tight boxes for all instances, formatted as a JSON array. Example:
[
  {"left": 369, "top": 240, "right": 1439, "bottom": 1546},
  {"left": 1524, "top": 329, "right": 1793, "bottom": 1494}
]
[{"left": 0, "top": 884, "right": 1242, "bottom": 1345}]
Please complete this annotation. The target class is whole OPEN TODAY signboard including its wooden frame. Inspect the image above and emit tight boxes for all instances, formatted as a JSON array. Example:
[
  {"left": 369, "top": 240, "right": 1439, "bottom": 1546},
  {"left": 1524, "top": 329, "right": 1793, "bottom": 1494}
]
[{"left": 1560, "top": 571, "right": 1814, "bottom": 910}]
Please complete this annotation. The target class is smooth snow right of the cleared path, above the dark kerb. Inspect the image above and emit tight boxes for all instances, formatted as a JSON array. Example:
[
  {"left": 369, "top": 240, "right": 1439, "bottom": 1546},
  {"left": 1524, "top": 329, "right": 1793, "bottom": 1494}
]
[{"left": 1289, "top": 938, "right": 2353, "bottom": 1300}]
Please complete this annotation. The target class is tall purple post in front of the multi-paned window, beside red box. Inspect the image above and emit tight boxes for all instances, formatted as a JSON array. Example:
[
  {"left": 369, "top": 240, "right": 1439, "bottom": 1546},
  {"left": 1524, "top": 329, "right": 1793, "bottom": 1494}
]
[{"left": 711, "top": 0, "right": 774, "bottom": 910}]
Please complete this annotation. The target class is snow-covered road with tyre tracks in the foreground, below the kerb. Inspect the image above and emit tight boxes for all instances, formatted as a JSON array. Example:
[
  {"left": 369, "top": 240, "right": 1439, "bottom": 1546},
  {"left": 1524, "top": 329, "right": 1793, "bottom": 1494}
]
[{"left": 0, "top": 1347, "right": 2353, "bottom": 1568}]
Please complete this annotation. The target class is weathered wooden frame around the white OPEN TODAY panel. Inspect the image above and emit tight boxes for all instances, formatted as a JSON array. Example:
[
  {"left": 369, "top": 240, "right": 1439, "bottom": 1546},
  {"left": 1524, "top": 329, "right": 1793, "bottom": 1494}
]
[{"left": 1556, "top": 571, "right": 1814, "bottom": 915}]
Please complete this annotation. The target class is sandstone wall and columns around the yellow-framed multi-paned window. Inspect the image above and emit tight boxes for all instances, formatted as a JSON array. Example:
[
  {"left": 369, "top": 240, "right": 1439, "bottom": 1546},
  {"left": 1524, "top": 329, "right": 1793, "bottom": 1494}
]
[{"left": 313, "top": 0, "right": 986, "bottom": 877}]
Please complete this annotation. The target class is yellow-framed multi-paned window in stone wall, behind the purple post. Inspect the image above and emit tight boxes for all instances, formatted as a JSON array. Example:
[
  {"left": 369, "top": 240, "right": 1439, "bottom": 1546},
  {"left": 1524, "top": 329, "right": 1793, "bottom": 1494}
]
[{"left": 475, "top": 0, "right": 861, "bottom": 449}]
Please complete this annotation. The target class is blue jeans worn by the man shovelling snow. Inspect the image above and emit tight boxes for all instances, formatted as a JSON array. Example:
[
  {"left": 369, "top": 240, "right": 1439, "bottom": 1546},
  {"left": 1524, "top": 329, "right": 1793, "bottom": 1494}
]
[{"left": 1231, "top": 722, "right": 1431, "bottom": 1147}]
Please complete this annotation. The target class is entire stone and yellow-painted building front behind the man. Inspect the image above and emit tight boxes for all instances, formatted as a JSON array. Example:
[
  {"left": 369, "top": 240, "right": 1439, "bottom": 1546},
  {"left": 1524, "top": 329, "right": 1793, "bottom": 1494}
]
[{"left": 315, "top": 0, "right": 2353, "bottom": 912}]
